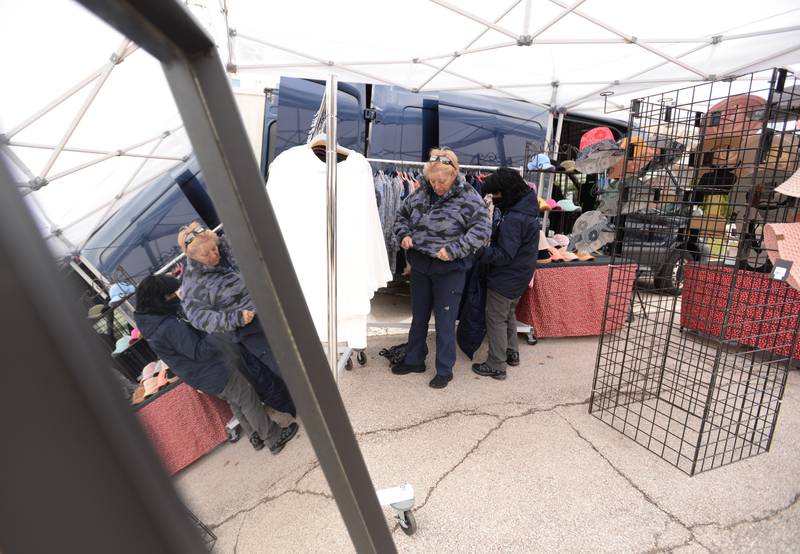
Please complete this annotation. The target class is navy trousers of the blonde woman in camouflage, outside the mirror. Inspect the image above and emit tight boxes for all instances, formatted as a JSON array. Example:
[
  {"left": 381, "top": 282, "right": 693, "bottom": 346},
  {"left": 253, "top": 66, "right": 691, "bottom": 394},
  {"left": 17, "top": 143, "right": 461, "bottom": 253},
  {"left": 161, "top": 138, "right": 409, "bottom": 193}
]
[{"left": 405, "top": 267, "right": 466, "bottom": 377}]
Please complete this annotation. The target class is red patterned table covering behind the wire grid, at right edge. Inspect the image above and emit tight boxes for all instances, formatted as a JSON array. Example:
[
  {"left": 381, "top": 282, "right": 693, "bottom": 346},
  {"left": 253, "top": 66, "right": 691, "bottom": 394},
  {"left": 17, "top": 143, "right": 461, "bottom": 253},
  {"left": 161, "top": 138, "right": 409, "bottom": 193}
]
[{"left": 681, "top": 264, "right": 800, "bottom": 359}]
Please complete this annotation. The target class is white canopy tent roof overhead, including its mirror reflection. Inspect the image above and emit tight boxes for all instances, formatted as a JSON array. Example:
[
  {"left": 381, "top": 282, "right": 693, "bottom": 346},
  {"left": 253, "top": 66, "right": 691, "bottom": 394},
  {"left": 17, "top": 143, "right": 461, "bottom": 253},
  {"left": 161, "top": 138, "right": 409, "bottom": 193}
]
[{"left": 0, "top": 0, "right": 800, "bottom": 254}]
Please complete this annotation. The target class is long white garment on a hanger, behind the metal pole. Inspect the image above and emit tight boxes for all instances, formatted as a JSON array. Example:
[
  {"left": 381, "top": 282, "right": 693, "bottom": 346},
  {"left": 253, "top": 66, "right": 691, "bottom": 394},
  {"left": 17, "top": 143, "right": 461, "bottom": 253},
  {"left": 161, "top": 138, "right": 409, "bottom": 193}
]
[{"left": 267, "top": 145, "right": 392, "bottom": 348}]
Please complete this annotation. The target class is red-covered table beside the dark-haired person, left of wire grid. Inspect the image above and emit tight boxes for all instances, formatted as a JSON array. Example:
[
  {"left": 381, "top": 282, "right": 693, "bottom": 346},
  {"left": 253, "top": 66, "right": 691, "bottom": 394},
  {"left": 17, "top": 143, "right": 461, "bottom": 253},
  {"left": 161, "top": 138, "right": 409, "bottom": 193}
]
[{"left": 517, "top": 258, "right": 636, "bottom": 338}]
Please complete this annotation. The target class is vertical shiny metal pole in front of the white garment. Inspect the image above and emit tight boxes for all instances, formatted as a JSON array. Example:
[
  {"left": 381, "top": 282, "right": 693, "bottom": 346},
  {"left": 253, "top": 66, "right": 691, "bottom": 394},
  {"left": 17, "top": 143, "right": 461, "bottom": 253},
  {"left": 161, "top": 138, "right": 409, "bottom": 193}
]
[{"left": 325, "top": 75, "right": 339, "bottom": 383}]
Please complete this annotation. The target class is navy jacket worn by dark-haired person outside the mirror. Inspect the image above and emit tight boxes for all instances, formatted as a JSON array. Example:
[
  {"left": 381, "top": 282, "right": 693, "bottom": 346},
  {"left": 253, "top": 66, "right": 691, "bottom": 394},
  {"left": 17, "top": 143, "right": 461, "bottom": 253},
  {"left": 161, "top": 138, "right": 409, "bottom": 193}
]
[{"left": 480, "top": 191, "right": 540, "bottom": 299}]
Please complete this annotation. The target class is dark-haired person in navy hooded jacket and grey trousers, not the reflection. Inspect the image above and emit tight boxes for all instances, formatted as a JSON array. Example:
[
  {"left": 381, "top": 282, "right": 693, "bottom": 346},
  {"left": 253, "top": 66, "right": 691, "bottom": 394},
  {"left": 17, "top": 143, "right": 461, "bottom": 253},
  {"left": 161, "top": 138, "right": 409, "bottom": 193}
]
[{"left": 472, "top": 167, "right": 540, "bottom": 380}]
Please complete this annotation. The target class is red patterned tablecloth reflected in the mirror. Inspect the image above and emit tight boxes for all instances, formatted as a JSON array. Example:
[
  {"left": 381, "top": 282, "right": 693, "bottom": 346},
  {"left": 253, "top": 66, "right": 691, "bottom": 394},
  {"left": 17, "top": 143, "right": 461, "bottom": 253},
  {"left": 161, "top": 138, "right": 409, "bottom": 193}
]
[{"left": 136, "top": 383, "right": 231, "bottom": 475}]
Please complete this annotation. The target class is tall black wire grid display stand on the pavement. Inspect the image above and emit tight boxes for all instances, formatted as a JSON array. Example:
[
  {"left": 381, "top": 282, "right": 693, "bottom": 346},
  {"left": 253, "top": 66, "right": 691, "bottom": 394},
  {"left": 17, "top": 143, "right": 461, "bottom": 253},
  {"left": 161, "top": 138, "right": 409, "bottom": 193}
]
[{"left": 590, "top": 70, "right": 800, "bottom": 475}]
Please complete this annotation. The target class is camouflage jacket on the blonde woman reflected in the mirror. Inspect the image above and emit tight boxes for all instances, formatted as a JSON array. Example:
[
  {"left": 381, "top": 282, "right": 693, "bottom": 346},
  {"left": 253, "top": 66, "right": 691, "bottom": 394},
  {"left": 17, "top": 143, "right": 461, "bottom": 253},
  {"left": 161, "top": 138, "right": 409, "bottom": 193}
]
[{"left": 181, "top": 239, "right": 255, "bottom": 333}]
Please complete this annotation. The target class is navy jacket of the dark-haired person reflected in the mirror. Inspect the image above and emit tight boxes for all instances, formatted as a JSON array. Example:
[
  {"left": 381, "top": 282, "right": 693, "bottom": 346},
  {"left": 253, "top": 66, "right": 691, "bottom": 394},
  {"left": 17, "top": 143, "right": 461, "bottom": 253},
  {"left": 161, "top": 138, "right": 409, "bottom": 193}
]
[{"left": 134, "top": 312, "right": 230, "bottom": 395}]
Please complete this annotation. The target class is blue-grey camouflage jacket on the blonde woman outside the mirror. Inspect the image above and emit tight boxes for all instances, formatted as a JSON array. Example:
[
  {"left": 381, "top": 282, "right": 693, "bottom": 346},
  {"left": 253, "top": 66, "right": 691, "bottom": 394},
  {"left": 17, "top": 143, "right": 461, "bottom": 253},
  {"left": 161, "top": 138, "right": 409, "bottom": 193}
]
[{"left": 394, "top": 175, "right": 491, "bottom": 260}]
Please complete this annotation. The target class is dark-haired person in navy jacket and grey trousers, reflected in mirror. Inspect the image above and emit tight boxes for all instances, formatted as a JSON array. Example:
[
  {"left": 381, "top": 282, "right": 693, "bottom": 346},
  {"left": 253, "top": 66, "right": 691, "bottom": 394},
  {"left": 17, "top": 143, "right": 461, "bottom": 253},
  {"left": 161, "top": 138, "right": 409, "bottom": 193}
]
[{"left": 135, "top": 275, "right": 298, "bottom": 454}]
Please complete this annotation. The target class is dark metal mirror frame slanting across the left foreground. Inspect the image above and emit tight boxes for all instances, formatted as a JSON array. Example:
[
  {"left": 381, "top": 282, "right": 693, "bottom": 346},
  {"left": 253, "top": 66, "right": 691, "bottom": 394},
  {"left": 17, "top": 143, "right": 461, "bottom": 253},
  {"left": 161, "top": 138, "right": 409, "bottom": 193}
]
[{"left": 0, "top": 0, "right": 396, "bottom": 553}]
